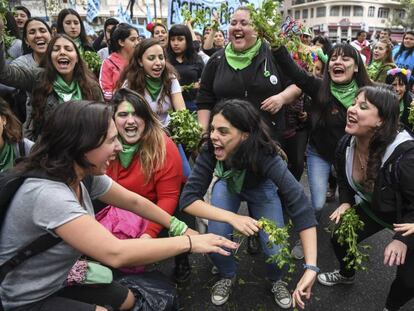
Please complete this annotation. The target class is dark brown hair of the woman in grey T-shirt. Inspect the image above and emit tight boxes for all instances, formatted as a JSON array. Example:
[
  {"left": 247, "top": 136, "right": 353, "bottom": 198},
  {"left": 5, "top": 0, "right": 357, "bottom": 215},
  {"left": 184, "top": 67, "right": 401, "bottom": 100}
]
[{"left": 17, "top": 100, "right": 112, "bottom": 184}]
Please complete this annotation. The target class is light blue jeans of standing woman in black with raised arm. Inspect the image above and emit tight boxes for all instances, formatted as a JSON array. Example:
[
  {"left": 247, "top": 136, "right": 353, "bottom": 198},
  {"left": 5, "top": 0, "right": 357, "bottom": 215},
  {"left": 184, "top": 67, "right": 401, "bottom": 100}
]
[{"left": 306, "top": 144, "right": 332, "bottom": 212}]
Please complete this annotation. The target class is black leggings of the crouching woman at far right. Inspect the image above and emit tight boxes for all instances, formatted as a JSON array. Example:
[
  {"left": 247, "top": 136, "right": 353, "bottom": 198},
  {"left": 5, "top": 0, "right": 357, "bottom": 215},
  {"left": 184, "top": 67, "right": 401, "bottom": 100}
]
[{"left": 331, "top": 208, "right": 414, "bottom": 310}]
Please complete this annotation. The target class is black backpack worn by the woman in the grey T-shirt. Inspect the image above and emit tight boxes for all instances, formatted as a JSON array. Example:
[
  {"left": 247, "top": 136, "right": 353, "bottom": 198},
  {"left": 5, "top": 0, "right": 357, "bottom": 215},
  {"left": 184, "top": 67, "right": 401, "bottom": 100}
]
[{"left": 0, "top": 170, "right": 93, "bottom": 286}]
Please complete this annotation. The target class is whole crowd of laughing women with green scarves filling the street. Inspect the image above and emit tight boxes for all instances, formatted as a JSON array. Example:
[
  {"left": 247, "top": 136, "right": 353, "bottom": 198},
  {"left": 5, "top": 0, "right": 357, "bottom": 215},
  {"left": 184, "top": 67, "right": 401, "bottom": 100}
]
[{"left": 0, "top": 7, "right": 414, "bottom": 311}]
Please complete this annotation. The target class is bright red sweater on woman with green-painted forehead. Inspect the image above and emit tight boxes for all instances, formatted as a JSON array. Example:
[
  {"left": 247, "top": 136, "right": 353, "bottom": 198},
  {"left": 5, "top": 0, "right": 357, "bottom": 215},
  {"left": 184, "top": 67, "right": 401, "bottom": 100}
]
[{"left": 107, "top": 135, "right": 184, "bottom": 238}]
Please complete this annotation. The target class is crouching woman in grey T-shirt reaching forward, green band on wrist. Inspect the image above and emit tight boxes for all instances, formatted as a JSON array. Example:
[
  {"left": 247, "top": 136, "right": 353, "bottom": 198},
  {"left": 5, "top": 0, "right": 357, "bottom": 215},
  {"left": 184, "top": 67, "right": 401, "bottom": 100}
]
[{"left": 0, "top": 101, "right": 237, "bottom": 311}]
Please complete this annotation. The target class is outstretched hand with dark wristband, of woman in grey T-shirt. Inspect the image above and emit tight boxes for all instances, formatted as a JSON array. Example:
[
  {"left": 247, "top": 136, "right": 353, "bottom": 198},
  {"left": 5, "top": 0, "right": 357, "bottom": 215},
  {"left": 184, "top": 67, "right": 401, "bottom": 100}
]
[{"left": 190, "top": 233, "right": 239, "bottom": 256}]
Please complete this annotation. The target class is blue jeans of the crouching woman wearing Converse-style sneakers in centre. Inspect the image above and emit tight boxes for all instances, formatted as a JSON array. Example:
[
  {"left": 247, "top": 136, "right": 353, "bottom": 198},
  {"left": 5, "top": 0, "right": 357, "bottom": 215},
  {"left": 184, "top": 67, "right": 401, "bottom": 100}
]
[{"left": 208, "top": 180, "right": 284, "bottom": 281}]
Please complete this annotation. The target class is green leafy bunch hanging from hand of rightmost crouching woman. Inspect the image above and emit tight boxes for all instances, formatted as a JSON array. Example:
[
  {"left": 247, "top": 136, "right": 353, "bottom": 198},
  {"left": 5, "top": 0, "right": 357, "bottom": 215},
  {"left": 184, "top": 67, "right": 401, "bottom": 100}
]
[{"left": 334, "top": 207, "right": 371, "bottom": 271}]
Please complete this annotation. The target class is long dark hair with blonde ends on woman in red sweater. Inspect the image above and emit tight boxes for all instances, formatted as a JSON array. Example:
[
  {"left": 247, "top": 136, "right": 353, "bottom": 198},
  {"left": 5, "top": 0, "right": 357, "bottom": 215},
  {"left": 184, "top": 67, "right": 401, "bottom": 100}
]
[{"left": 111, "top": 89, "right": 167, "bottom": 183}]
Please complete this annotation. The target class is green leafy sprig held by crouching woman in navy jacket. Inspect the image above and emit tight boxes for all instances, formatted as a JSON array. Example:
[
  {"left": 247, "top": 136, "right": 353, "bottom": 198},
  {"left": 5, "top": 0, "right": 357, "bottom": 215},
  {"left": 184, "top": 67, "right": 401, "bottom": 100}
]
[{"left": 258, "top": 217, "right": 295, "bottom": 273}]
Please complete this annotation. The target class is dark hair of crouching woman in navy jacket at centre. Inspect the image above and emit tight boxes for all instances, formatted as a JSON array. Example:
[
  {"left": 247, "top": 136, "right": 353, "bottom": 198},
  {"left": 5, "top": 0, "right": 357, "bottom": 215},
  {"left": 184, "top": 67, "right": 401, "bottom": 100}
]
[{"left": 207, "top": 99, "right": 279, "bottom": 173}]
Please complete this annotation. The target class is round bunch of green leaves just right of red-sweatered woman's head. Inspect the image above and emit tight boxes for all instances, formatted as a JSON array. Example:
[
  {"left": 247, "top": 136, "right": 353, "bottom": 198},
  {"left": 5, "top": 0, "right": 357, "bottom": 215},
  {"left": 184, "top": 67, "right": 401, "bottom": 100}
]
[{"left": 168, "top": 109, "right": 202, "bottom": 151}]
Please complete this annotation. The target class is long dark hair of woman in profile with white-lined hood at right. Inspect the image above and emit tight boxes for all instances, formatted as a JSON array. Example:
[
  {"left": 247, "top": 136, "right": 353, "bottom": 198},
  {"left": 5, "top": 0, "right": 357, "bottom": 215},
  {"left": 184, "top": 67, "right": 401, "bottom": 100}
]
[{"left": 356, "top": 86, "right": 400, "bottom": 191}]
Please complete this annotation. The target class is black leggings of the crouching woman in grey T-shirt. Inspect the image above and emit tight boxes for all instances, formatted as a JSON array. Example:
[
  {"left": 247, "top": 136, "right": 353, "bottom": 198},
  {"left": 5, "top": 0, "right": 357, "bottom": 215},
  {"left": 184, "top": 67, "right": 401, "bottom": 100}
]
[{"left": 13, "top": 282, "right": 128, "bottom": 311}]
